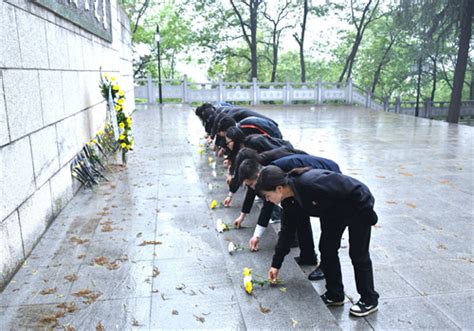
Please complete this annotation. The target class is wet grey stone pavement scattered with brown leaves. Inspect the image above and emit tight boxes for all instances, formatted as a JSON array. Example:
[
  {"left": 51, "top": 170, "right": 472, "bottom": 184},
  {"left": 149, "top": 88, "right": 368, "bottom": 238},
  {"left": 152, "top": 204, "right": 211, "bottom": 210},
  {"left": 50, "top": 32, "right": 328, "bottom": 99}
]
[{"left": 0, "top": 105, "right": 474, "bottom": 330}]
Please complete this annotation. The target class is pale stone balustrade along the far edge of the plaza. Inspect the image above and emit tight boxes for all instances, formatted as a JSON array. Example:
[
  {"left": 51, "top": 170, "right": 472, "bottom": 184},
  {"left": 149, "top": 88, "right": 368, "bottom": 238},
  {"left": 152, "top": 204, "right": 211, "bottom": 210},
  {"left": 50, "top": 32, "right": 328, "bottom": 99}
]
[{"left": 135, "top": 75, "right": 474, "bottom": 118}]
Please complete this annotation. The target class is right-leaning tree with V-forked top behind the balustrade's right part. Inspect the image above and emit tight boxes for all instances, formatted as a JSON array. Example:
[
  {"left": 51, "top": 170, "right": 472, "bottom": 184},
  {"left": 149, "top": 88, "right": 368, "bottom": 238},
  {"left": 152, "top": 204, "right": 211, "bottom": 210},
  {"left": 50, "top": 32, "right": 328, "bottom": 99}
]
[{"left": 339, "top": 0, "right": 380, "bottom": 83}]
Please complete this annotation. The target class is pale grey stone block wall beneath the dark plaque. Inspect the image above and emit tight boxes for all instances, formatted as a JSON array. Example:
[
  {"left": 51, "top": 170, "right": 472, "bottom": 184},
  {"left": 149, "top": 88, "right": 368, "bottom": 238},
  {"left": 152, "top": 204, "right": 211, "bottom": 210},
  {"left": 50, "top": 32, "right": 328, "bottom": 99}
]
[{"left": 0, "top": 0, "right": 134, "bottom": 289}]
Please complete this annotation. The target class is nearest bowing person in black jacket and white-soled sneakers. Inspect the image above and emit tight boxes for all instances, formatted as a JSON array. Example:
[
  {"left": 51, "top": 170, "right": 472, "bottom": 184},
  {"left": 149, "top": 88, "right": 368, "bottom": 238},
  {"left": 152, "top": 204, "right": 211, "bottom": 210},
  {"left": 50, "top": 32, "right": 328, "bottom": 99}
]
[{"left": 256, "top": 165, "right": 379, "bottom": 316}]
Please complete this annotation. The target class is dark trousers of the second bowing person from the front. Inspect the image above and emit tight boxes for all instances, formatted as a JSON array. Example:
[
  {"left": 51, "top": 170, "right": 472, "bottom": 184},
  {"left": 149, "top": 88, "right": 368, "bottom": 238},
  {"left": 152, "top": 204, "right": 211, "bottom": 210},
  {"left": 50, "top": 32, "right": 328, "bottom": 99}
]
[{"left": 281, "top": 203, "right": 317, "bottom": 260}]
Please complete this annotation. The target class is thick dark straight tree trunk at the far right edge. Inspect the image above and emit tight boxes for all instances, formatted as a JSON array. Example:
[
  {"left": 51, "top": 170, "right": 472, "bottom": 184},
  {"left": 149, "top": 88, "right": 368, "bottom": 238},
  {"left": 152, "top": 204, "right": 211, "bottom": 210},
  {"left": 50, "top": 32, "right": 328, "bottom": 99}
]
[{"left": 448, "top": 0, "right": 474, "bottom": 123}]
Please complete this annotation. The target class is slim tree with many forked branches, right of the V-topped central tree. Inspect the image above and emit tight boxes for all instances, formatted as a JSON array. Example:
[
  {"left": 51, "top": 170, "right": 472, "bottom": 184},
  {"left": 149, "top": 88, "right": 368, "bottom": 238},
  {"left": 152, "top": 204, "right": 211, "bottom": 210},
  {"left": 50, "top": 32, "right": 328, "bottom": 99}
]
[{"left": 262, "top": 0, "right": 292, "bottom": 83}]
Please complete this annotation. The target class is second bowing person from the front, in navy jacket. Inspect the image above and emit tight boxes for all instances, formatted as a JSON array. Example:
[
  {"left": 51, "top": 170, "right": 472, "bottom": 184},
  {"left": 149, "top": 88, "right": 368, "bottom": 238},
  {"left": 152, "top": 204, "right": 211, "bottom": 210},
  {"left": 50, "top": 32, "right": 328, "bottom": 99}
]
[{"left": 236, "top": 154, "right": 341, "bottom": 280}]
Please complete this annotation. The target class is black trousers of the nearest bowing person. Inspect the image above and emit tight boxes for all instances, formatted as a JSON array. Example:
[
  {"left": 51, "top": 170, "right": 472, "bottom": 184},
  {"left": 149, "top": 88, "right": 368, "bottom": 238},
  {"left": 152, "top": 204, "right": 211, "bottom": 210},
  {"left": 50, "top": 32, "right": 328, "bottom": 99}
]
[{"left": 319, "top": 218, "right": 379, "bottom": 304}]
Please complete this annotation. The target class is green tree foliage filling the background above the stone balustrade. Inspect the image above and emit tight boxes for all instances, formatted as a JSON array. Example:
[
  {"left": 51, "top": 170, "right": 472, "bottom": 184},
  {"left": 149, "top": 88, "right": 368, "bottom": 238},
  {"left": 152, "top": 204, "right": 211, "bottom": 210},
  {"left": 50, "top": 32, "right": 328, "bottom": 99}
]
[{"left": 122, "top": 0, "right": 474, "bottom": 119}]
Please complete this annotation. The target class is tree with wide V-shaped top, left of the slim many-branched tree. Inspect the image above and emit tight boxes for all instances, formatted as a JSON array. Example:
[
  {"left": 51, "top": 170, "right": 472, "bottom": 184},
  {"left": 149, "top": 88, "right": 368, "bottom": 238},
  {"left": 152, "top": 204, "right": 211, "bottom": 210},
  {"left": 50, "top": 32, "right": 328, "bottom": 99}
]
[{"left": 230, "top": 0, "right": 263, "bottom": 80}]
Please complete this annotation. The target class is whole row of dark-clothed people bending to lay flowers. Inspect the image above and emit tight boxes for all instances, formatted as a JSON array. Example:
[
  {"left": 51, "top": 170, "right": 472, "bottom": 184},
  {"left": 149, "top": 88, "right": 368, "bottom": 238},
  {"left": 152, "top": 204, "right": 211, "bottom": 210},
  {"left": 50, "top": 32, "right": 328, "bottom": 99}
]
[{"left": 195, "top": 103, "right": 379, "bottom": 317}]
